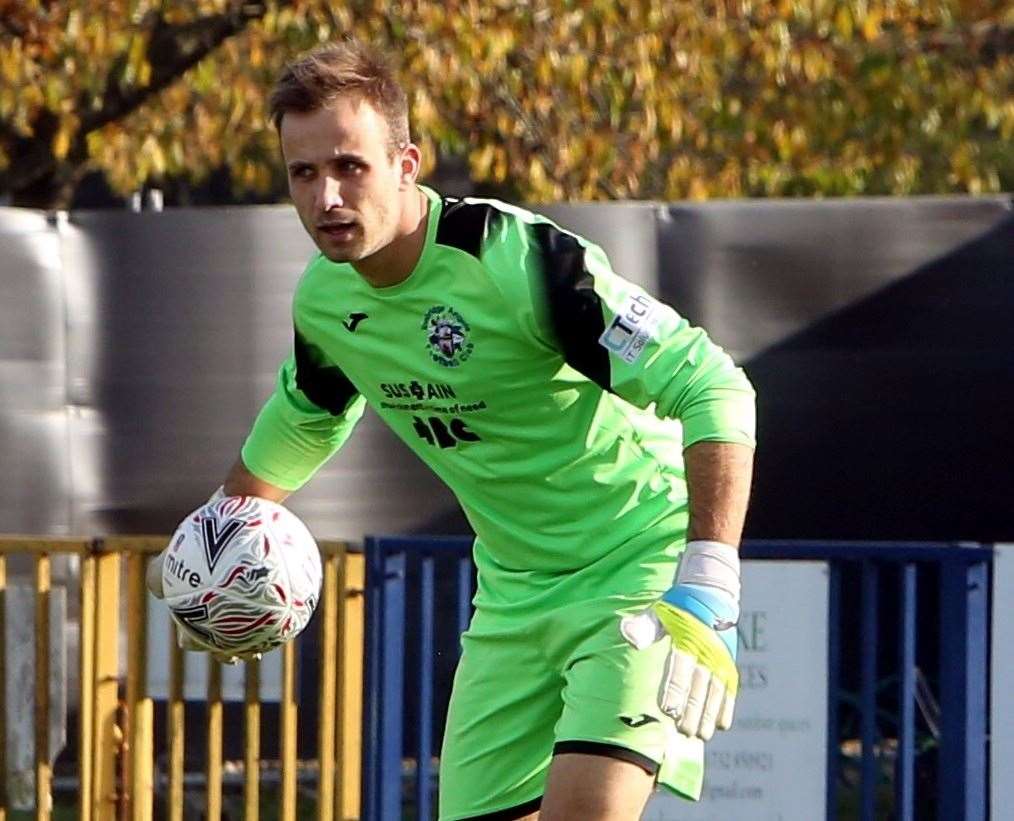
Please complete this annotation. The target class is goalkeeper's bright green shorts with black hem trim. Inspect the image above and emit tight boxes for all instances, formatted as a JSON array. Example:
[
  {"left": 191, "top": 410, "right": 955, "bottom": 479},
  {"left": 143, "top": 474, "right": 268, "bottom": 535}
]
[{"left": 440, "top": 575, "right": 704, "bottom": 821}]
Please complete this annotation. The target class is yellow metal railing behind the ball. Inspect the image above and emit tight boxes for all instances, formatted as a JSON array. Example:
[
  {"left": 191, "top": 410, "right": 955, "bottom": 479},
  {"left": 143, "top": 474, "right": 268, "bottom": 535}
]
[{"left": 0, "top": 536, "right": 364, "bottom": 821}]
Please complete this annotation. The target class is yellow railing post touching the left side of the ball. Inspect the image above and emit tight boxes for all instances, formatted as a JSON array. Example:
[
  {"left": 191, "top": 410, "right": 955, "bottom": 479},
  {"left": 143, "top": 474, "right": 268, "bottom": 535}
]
[{"left": 125, "top": 547, "right": 154, "bottom": 821}]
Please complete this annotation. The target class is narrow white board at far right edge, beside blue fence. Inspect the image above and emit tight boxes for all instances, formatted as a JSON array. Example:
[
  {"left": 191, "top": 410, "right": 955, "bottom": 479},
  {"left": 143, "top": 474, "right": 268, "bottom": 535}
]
[{"left": 990, "top": 544, "right": 1014, "bottom": 819}]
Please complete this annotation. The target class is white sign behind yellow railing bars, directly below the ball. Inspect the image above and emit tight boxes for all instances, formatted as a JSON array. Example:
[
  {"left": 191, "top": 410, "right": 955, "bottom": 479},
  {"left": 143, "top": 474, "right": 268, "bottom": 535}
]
[{"left": 148, "top": 596, "right": 282, "bottom": 701}]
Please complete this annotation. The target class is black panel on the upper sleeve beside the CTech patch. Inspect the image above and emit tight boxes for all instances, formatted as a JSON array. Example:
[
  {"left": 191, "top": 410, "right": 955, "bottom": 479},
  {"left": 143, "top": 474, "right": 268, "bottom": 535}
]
[{"left": 530, "top": 223, "right": 612, "bottom": 390}]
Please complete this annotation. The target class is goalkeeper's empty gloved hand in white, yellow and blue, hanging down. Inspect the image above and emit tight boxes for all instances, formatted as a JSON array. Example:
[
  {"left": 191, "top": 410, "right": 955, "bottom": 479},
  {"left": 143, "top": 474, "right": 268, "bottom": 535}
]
[{"left": 620, "top": 541, "right": 739, "bottom": 741}]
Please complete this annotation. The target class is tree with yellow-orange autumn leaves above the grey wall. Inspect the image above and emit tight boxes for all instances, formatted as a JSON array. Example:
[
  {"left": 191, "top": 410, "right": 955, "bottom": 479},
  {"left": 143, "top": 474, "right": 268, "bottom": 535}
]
[{"left": 0, "top": 0, "right": 1014, "bottom": 208}]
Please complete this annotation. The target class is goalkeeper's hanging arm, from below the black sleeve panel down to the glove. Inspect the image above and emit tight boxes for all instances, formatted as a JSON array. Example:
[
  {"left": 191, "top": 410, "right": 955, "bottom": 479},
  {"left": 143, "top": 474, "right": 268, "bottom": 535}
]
[{"left": 563, "top": 246, "right": 755, "bottom": 741}]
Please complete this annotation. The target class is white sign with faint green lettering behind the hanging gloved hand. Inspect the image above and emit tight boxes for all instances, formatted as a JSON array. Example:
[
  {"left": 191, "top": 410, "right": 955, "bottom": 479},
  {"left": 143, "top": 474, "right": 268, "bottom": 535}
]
[{"left": 642, "top": 562, "right": 827, "bottom": 821}]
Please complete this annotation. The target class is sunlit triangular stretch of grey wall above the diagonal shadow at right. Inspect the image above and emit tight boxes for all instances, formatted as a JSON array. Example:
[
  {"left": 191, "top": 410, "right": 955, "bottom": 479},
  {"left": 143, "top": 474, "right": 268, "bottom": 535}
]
[{"left": 658, "top": 197, "right": 1009, "bottom": 360}]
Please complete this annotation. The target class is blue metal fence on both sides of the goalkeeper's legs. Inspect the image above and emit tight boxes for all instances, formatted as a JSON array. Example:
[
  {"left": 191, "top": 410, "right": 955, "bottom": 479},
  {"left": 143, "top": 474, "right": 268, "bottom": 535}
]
[{"left": 363, "top": 536, "right": 993, "bottom": 821}]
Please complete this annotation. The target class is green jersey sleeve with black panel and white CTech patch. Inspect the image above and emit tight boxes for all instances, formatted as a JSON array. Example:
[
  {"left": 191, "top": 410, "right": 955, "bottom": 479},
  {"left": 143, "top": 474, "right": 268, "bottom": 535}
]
[{"left": 484, "top": 216, "right": 755, "bottom": 447}]
